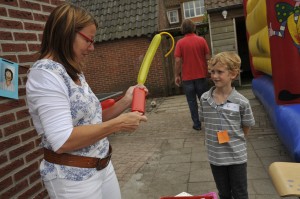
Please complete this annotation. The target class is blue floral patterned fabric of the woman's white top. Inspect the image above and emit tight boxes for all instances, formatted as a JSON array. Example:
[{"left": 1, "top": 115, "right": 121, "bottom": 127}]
[{"left": 30, "top": 59, "right": 109, "bottom": 181}]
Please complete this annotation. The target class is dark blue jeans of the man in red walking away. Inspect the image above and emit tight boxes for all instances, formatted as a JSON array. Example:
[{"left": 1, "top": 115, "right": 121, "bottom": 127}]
[{"left": 182, "top": 78, "right": 208, "bottom": 127}]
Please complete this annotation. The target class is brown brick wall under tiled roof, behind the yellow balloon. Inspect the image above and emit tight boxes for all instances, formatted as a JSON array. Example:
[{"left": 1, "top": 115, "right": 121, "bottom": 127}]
[{"left": 83, "top": 37, "right": 166, "bottom": 96}]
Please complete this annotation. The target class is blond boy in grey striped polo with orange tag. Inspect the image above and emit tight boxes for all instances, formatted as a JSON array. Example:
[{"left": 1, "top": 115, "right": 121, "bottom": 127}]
[{"left": 199, "top": 52, "right": 255, "bottom": 199}]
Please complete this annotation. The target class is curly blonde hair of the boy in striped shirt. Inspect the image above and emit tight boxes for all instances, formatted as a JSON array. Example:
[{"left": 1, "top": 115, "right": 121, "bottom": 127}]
[{"left": 208, "top": 51, "right": 241, "bottom": 75}]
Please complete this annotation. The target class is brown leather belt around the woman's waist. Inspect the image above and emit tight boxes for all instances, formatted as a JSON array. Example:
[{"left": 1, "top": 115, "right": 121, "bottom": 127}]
[{"left": 44, "top": 145, "right": 112, "bottom": 170}]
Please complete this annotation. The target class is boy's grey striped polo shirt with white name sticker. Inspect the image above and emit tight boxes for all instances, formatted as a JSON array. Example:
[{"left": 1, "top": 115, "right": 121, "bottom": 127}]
[{"left": 199, "top": 87, "right": 255, "bottom": 166}]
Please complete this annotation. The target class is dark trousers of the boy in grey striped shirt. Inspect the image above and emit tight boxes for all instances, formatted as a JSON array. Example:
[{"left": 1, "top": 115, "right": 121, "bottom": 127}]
[{"left": 210, "top": 163, "right": 248, "bottom": 199}]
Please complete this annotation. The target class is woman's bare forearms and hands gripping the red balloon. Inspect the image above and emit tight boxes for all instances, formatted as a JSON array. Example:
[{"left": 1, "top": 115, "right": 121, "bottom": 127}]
[{"left": 56, "top": 83, "right": 148, "bottom": 153}]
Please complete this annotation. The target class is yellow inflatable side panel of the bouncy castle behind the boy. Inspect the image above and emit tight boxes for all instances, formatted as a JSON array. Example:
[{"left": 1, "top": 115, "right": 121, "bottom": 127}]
[{"left": 246, "top": 0, "right": 272, "bottom": 75}]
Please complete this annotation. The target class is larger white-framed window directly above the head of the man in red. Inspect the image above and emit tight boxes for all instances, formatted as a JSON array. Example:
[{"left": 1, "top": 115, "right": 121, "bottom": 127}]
[{"left": 183, "top": 0, "right": 205, "bottom": 19}]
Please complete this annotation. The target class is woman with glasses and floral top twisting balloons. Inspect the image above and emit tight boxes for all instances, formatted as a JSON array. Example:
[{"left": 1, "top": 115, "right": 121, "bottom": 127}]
[{"left": 26, "top": 3, "right": 147, "bottom": 199}]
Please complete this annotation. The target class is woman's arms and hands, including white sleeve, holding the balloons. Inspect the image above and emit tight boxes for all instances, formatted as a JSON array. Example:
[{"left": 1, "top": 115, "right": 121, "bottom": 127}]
[{"left": 26, "top": 70, "right": 147, "bottom": 153}]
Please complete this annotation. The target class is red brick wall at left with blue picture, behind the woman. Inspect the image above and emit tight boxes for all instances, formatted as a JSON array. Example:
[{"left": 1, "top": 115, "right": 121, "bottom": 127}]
[{"left": 0, "top": 0, "right": 60, "bottom": 198}]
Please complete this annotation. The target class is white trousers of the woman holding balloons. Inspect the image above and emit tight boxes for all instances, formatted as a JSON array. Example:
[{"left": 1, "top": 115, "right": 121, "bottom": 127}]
[{"left": 44, "top": 161, "right": 121, "bottom": 199}]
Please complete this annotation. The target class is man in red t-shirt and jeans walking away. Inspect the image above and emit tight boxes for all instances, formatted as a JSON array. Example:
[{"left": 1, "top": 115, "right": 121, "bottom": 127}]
[{"left": 174, "top": 19, "right": 210, "bottom": 131}]
